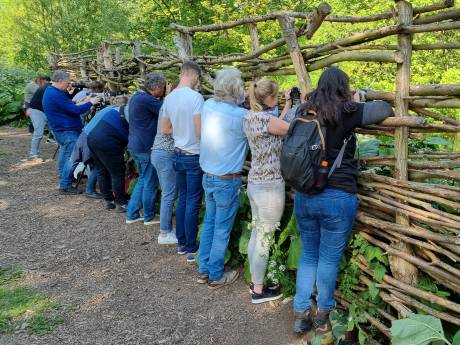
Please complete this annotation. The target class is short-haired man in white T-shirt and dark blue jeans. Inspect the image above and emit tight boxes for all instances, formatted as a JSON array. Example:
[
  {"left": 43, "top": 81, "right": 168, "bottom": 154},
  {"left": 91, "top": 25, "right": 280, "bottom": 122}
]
[{"left": 161, "top": 61, "right": 204, "bottom": 263}]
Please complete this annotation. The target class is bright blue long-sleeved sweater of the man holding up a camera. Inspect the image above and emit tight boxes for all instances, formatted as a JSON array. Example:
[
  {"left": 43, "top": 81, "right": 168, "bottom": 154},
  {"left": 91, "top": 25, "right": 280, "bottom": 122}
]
[{"left": 42, "top": 85, "right": 92, "bottom": 132}]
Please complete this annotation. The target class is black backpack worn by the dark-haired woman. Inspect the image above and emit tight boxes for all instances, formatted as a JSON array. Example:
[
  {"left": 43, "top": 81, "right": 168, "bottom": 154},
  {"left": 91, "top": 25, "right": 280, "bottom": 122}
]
[{"left": 280, "top": 111, "right": 353, "bottom": 194}]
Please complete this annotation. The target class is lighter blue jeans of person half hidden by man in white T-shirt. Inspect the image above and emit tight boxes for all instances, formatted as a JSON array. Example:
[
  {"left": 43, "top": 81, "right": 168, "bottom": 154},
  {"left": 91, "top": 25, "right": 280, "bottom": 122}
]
[{"left": 150, "top": 149, "right": 176, "bottom": 233}]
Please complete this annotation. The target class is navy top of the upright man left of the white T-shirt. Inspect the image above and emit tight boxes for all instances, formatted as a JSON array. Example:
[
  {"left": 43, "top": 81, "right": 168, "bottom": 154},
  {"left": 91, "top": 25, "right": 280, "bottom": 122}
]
[{"left": 128, "top": 91, "right": 163, "bottom": 153}]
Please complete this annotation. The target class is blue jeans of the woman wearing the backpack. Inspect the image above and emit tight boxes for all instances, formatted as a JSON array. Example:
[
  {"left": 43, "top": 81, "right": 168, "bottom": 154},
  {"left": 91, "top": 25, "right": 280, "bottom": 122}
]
[{"left": 294, "top": 188, "right": 358, "bottom": 312}]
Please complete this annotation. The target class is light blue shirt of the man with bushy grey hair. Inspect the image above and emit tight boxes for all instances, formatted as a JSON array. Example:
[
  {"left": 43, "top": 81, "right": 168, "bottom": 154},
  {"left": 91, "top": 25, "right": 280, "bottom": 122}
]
[{"left": 200, "top": 99, "right": 248, "bottom": 176}]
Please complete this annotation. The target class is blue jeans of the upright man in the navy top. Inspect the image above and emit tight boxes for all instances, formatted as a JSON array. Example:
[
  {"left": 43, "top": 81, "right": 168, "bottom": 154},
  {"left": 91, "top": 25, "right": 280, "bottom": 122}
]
[{"left": 126, "top": 152, "right": 158, "bottom": 222}]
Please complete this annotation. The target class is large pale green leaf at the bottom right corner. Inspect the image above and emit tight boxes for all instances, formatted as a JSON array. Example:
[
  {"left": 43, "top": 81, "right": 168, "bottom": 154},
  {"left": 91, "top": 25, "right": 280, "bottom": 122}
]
[{"left": 391, "top": 314, "right": 444, "bottom": 345}]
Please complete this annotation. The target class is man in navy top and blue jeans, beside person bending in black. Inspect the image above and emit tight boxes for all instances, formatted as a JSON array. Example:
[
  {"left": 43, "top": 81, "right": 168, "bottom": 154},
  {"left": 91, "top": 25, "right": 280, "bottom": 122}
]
[{"left": 126, "top": 73, "right": 166, "bottom": 225}]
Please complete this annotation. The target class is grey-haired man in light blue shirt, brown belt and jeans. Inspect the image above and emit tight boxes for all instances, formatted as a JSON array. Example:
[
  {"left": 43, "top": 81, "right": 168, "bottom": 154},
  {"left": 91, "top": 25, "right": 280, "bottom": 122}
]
[{"left": 197, "top": 68, "right": 248, "bottom": 289}]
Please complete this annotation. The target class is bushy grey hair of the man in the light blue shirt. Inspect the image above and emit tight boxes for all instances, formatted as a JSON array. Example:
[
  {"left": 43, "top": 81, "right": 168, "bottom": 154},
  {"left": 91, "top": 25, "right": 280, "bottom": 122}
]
[{"left": 214, "top": 67, "right": 244, "bottom": 104}]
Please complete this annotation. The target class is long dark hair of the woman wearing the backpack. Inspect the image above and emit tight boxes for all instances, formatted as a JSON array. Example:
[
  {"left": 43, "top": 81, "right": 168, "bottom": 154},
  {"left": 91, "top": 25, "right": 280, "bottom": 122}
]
[{"left": 300, "top": 67, "right": 356, "bottom": 128}]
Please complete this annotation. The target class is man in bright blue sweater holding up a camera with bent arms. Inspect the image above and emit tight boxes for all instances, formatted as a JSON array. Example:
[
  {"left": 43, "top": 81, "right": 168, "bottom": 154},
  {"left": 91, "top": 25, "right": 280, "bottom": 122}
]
[{"left": 42, "top": 70, "right": 100, "bottom": 194}]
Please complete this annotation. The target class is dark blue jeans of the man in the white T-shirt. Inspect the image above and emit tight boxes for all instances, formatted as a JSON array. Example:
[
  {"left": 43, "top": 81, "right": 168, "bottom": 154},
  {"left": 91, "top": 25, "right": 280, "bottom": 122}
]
[{"left": 174, "top": 152, "right": 203, "bottom": 253}]
